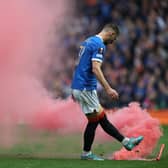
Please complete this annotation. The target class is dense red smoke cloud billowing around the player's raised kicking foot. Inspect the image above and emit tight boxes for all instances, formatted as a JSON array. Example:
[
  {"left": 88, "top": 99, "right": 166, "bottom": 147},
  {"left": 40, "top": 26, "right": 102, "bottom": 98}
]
[{"left": 111, "top": 103, "right": 162, "bottom": 160}]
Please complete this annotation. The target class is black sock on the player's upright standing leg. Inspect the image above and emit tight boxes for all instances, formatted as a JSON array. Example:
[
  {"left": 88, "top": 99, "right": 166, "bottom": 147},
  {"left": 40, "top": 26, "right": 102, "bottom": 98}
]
[{"left": 83, "top": 122, "right": 99, "bottom": 151}]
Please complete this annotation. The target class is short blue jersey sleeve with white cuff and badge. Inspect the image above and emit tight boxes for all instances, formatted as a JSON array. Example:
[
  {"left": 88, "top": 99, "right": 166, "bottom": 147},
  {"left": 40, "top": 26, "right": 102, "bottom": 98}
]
[{"left": 91, "top": 47, "right": 104, "bottom": 62}]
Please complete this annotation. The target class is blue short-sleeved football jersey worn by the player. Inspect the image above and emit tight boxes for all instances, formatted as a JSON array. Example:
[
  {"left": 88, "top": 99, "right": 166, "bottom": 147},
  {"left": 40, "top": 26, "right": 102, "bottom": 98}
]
[{"left": 71, "top": 35, "right": 105, "bottom": 90}]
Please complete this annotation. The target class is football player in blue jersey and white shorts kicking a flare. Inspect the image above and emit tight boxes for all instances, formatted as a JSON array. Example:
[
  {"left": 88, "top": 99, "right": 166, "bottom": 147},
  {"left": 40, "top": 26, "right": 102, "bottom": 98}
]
[{"left": 71, "top": 23, "right": 143, "bottom": 160}]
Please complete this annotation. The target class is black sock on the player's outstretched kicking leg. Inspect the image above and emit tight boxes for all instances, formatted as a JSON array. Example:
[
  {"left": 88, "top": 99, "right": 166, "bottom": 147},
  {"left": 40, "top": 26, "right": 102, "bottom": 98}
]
[{"left": 99, "top": 115, "right": 124, "bottom": 142}]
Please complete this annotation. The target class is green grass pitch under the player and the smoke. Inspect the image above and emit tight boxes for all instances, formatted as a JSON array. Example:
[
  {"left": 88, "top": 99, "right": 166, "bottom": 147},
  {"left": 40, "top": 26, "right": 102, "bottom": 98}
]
[{"left": 0, "top": 126, "right": 168, "bottom": 168}]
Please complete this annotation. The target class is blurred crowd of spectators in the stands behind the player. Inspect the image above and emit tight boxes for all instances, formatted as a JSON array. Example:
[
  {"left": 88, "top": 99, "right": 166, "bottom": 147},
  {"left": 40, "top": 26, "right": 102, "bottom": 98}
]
[{"left": 48, "top": 0, "right": 168, "bottom": 108}]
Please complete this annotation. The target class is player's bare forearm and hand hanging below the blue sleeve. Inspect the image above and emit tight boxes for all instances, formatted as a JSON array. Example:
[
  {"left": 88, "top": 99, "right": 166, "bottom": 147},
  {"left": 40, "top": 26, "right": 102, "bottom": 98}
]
[{"left": 92, "top": 60, "right": 118, "bottom": 99}]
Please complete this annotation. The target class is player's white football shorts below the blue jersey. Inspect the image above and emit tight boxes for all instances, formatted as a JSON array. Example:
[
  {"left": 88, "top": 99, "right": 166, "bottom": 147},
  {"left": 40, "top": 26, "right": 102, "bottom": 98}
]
[{"left": 72, "top": 89, "right": 103, "bottom": 115}]
